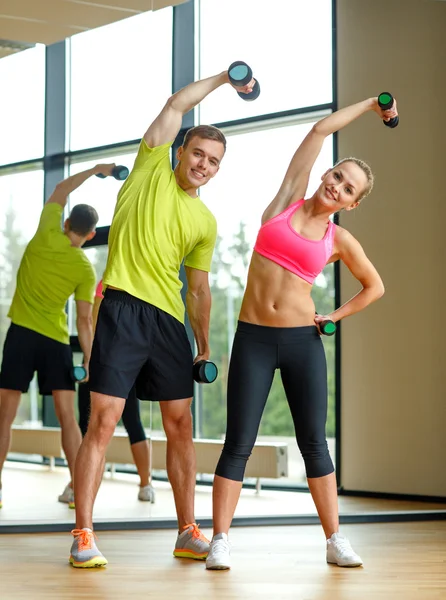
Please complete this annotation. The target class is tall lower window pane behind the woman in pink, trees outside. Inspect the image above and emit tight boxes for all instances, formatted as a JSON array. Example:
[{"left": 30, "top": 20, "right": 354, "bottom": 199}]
[{"left": 197, "top": 123, "right": 334, "bottom": 483}]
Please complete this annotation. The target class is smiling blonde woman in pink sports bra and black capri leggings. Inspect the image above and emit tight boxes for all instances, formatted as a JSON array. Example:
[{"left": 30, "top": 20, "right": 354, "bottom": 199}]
[{"left": 206, "top": 98, "right": 397, "bottom": 569}]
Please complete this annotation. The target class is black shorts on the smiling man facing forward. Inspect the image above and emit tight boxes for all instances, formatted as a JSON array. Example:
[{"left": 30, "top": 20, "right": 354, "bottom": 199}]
[{"left": 90, "top": 289, "right": 193, "bottom": 401}]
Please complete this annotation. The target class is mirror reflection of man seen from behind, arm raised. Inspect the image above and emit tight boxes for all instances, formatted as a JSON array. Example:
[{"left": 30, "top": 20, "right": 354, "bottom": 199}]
[{"left": 0, "top": 165, "right": 114, "bottom": 506}]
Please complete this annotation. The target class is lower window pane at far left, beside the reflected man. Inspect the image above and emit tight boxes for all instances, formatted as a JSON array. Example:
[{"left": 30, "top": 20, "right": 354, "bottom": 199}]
[{"left": 0, "top": 166, "right": 43, "bottom": 425}]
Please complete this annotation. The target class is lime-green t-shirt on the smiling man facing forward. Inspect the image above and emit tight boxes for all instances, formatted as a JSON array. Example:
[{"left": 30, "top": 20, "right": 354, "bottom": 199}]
[{"left": 103, "top": 139, "right": 217, "bottom": 322}]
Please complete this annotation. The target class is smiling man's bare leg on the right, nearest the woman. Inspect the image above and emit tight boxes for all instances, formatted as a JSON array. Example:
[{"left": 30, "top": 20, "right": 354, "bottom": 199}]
[{"left": 160, "top": 398, "right": 196, "bottom": 531}]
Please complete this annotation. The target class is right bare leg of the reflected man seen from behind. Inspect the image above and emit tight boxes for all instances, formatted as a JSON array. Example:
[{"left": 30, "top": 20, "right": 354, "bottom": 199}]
[{"left": 53, "top": 390, "right": 82, "bottom": 481}]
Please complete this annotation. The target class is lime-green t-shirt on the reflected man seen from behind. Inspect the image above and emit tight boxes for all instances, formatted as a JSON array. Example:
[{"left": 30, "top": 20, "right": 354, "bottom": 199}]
[{"left": 8, "top": 202, "right": 96, "bottom": 344}]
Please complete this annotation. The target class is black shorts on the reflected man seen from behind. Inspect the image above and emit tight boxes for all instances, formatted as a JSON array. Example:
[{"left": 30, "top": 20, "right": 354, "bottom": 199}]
[{"left": 0, "top": 323, "right": 75, "bottom": 395}]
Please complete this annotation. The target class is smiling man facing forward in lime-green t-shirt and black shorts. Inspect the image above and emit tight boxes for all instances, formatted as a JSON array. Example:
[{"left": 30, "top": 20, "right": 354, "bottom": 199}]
[{"left": 70, "top": 67, "right": 254, "bottom": 567}]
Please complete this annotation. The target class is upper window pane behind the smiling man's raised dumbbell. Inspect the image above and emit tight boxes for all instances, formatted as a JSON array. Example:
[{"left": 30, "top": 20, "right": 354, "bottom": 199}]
[{"left": 199, "top": 0, "right": 332, "bottom": 123}]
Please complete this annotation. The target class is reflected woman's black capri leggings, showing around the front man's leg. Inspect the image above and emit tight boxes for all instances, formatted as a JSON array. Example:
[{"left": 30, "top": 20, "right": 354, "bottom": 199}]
[{"left": 77, "top": 383, "right": 146, "bottom": 444}]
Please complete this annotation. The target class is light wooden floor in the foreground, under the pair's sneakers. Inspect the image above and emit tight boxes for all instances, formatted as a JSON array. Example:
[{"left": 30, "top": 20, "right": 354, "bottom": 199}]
[{"left": 0, "top": 521, "right": 446, "bottom": 600}]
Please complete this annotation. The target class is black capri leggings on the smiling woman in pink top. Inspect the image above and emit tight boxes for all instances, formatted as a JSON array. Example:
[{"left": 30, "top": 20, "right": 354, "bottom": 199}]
[{"left": 215, "top": 321, "right": 334, "bottom": 481}]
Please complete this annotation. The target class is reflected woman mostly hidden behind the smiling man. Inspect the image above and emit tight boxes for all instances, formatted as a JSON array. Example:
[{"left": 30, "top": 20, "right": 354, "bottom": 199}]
[{"left": 76, "top": 281, "right": 155, "bottom": 506}]
